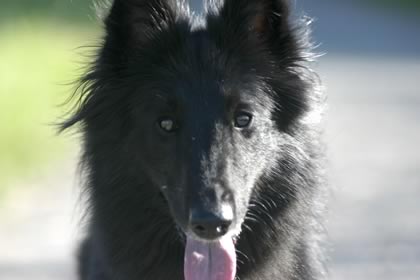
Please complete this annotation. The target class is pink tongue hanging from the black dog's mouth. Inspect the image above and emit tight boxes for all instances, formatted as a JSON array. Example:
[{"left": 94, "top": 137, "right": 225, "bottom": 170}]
[{"left": 184, "top": 237, "right": 236, "bottom": 280}]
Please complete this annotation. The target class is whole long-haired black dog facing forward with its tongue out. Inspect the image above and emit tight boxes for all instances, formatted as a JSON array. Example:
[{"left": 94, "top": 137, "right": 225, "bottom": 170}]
[{"left": 63, "top": 0, "right": 324, "bottom": 280}]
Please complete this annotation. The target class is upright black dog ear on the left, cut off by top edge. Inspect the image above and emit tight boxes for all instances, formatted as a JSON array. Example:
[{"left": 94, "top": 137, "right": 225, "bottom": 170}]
[{"left": 105, "top": 0, "right": 177, "bottom": 48}]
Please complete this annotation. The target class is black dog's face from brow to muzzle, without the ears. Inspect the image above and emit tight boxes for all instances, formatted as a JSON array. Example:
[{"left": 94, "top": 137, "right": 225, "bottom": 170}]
[{"left": 130, "top": 50, "right": 279, "bottom": 239}]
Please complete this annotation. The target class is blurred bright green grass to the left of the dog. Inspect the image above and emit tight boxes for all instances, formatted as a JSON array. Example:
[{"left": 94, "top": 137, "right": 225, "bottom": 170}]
[{"left": 0, "top": 18, "right": 98, "bottom": 191}]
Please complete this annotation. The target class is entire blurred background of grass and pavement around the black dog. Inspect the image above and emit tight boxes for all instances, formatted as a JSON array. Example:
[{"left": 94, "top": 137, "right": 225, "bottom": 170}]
[{"left": 0, "top": 0, "right": 420, "bottom": 280}]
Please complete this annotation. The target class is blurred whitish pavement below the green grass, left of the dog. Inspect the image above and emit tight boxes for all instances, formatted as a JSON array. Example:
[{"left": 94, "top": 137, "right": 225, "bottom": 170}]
[{"left": 0, "top": 159, "right": 81, "bottom": 280}]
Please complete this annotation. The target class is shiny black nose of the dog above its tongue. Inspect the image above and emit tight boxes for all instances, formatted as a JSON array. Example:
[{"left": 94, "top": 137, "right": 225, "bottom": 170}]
[{"left": 190, "top": 207, "right": 233, "bottom": 240}]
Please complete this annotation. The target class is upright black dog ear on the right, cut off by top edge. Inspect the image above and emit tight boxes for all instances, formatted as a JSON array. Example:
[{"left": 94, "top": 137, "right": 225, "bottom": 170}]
[{"left": 215, "top": 0, "right": 290, "bottom": 42}]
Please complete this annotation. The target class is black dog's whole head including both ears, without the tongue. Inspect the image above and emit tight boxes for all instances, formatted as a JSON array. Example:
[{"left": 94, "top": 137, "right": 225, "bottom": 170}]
[{"left": 65, "top": 0, "right": 306, "bottom": 240}]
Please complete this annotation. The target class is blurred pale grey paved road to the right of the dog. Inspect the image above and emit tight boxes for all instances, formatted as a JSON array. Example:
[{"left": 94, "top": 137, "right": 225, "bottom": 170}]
[{"left": 321, "top": 57, "right": 420, "bottom": 280}]
